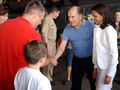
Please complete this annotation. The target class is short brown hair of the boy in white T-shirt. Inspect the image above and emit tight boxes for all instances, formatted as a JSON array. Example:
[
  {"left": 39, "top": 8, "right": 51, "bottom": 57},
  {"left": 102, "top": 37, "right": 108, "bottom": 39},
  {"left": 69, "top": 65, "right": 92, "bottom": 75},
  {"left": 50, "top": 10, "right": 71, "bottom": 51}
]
[{"left": 24, "top": 40, "right": 47, "bottom": 64}]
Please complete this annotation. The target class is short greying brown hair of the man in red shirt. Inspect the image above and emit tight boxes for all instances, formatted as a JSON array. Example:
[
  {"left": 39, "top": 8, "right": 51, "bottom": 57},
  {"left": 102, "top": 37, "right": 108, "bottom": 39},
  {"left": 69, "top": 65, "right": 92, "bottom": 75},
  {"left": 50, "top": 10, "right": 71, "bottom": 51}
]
[{"left": 24, "top": 0, "right": 45, "bottom": 15}]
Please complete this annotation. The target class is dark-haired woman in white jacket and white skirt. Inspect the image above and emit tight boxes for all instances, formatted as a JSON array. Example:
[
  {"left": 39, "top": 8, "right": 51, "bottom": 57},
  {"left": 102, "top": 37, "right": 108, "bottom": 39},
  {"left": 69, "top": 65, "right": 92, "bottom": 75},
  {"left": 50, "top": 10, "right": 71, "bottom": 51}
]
[{"left": 92, "top": 4, "right": 118, "bottom": 90}]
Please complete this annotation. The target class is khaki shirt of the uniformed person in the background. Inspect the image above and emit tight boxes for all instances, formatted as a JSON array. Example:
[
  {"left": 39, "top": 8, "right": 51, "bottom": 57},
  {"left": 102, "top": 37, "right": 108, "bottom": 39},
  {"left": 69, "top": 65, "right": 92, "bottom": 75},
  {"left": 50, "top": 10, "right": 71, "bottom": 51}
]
[{"left": 42, "top": 15, "right": 57, "bottom": 55}]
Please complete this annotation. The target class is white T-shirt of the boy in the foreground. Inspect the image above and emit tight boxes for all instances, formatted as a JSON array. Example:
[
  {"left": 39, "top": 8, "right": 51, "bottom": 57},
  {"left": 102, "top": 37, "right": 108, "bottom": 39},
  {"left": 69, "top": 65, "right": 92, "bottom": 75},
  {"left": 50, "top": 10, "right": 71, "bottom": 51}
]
[{"left": 14, "top": 67, "right": 51, "bottom": 90}]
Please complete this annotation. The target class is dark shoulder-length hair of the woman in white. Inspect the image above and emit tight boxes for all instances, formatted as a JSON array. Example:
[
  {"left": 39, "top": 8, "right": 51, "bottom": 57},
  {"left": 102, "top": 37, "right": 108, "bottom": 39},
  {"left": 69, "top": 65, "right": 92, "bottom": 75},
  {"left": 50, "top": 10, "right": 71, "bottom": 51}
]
[{"left": 92, "top": 4, "right": 116, "bottom": 29}]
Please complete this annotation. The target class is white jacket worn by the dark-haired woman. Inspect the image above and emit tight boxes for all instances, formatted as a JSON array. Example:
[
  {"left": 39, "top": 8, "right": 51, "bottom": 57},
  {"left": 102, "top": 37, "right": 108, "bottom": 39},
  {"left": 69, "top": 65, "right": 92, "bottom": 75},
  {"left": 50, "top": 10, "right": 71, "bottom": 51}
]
[{"left": 93, "top": 25, "right": 118, "bottom": 76}]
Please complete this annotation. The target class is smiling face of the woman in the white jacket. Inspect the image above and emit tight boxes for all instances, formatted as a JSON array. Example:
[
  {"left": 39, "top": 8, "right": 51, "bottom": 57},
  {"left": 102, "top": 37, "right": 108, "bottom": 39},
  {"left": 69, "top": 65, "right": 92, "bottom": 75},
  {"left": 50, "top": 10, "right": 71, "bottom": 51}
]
[{"left": 92, "top": 10, "right": 103, "bottom": 25}]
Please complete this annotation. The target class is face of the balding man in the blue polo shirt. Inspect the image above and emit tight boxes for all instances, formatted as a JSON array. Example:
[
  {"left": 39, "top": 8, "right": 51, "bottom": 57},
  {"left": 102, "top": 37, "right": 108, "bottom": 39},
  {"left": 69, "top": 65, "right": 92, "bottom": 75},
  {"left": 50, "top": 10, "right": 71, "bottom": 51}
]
[{"left": 68, "top": 8, "right": 82, "bottom": 28}]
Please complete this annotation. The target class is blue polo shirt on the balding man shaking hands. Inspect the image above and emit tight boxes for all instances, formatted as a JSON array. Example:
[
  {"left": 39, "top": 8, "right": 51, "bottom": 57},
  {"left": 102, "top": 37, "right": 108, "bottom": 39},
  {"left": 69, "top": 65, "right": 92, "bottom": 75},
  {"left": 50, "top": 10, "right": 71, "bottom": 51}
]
[{"left": 62, "top": 19, "right": 94, "bottom": 58}]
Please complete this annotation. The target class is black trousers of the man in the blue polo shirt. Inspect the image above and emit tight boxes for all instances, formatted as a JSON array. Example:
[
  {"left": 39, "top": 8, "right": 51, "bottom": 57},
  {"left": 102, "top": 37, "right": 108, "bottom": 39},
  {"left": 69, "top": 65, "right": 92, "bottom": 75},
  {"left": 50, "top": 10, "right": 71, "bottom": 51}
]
[{"left": 71, "top": 56, "right": 95, "bottom": 90}]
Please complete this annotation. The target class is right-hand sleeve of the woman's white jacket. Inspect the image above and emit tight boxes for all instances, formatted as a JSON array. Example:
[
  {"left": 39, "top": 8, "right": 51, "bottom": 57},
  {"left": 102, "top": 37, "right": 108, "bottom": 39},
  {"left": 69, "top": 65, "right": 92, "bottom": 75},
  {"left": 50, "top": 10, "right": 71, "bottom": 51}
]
[{"left": 106, "top": 27, "right": 118, "bottom": 76}]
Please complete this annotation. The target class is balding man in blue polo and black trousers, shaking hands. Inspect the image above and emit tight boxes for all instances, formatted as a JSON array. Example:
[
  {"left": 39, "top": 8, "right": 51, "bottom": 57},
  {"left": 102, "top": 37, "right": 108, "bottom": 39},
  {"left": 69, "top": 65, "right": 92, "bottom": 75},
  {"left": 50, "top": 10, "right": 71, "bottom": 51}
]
[{"left": 53, "top": 6, "right": 95, "bottom": 90}]
